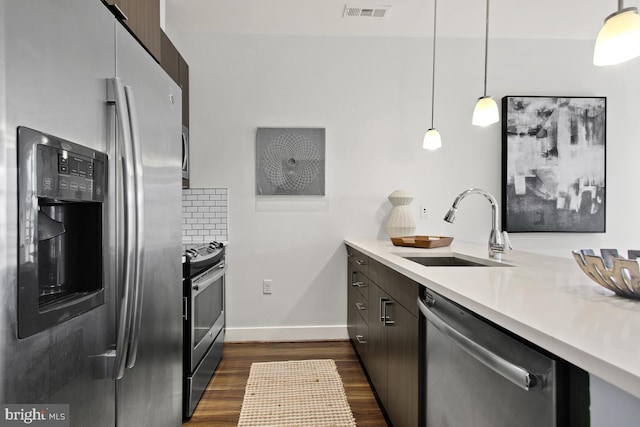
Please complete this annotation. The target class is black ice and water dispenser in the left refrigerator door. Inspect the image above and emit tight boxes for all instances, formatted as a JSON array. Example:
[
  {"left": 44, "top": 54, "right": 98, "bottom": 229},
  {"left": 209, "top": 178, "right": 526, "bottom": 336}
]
[{"left": 17, "top": 127, "right": 107, "bottom": 338}]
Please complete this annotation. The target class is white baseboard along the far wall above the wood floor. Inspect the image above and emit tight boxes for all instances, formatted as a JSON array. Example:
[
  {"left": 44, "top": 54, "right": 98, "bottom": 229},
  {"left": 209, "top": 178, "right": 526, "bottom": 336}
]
[{"left": 224, "top": 325, "right": 349, "bottom": 342}]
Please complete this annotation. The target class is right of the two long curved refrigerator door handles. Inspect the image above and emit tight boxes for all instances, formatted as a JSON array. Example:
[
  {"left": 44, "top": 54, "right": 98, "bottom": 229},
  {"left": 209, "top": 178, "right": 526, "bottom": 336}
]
[{"left": 124, "top": 86, "right": 144, "bottom": 368}]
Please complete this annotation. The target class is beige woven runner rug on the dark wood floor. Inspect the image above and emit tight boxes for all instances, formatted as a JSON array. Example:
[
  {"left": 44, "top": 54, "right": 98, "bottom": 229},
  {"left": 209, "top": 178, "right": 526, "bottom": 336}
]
[{"left": 238, "top": 359, "right": 356, "bottom": 427}]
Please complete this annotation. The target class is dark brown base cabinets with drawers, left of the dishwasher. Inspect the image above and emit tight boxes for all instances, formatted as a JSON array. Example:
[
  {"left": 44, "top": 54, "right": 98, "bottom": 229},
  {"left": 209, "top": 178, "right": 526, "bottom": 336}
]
[{"left": 347, "top": 246, "right": 420, "bottom": 427}]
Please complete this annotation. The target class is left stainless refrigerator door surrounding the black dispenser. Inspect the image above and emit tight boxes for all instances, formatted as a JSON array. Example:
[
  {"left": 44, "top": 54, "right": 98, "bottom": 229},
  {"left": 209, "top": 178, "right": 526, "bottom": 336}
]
[{"left": 0, "top": 0, "right": 115, "bottom": 427}]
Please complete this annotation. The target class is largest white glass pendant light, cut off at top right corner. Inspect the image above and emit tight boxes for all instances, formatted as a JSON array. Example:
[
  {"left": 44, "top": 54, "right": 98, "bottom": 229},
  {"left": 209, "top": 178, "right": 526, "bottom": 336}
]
[{"left": 593, "top": 0, "right": 640, "bottom": 65}]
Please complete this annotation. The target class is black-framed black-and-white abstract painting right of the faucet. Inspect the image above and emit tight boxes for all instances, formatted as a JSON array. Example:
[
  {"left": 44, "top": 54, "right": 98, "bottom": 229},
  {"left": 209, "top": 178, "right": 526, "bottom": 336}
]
[{"left": 502, "top": 96, "right": 607, "bottom": 233}]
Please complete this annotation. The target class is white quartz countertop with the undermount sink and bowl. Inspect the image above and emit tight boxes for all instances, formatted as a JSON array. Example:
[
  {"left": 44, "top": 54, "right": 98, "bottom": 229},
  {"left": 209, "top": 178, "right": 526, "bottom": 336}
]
[{"left": 345, "top": 238, "right": 640, "bottom": 398}]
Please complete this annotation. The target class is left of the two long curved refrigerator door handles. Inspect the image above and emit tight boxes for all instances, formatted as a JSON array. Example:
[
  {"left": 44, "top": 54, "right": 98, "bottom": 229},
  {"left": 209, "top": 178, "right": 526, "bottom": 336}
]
[{"left": 108, "top": 77, "right": 136, "bottom": 379}]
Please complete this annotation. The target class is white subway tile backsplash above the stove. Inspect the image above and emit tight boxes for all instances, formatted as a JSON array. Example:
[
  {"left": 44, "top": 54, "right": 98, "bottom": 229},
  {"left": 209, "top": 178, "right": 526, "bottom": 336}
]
[{"left": 182, "top": 188, "right": 229, "bottom": 244}]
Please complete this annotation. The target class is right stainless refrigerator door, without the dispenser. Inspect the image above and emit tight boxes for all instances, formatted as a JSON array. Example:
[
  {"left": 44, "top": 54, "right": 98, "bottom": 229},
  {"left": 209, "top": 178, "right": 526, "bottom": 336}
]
[{"left": 116, "top": 25, "right": 182, "bottom": 427}]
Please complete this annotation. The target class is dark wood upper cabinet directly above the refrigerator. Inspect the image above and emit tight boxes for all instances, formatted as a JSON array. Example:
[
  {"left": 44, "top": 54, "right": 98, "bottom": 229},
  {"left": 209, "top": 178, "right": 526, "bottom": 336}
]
[{"left": 102, "top": 0, "right": 161, "bottom": 62}]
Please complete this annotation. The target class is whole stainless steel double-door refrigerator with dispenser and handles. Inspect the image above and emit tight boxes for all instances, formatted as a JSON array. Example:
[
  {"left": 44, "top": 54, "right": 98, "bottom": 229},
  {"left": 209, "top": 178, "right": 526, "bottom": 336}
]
[{"left": 0, "top": 0, "right": 182, "bottom": 427}]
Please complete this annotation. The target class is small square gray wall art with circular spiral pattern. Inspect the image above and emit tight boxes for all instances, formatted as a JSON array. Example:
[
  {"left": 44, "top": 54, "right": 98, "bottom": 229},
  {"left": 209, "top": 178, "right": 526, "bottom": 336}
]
[{"left": 256, "top": 128, "right": 325, "bottom": 196}]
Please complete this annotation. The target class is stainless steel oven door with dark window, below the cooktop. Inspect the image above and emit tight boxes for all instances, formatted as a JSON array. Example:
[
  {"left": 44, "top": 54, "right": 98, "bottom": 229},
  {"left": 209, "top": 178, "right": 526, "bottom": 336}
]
[{"left": 189, "top": 262, "right": 227, "bottom": 372}]
